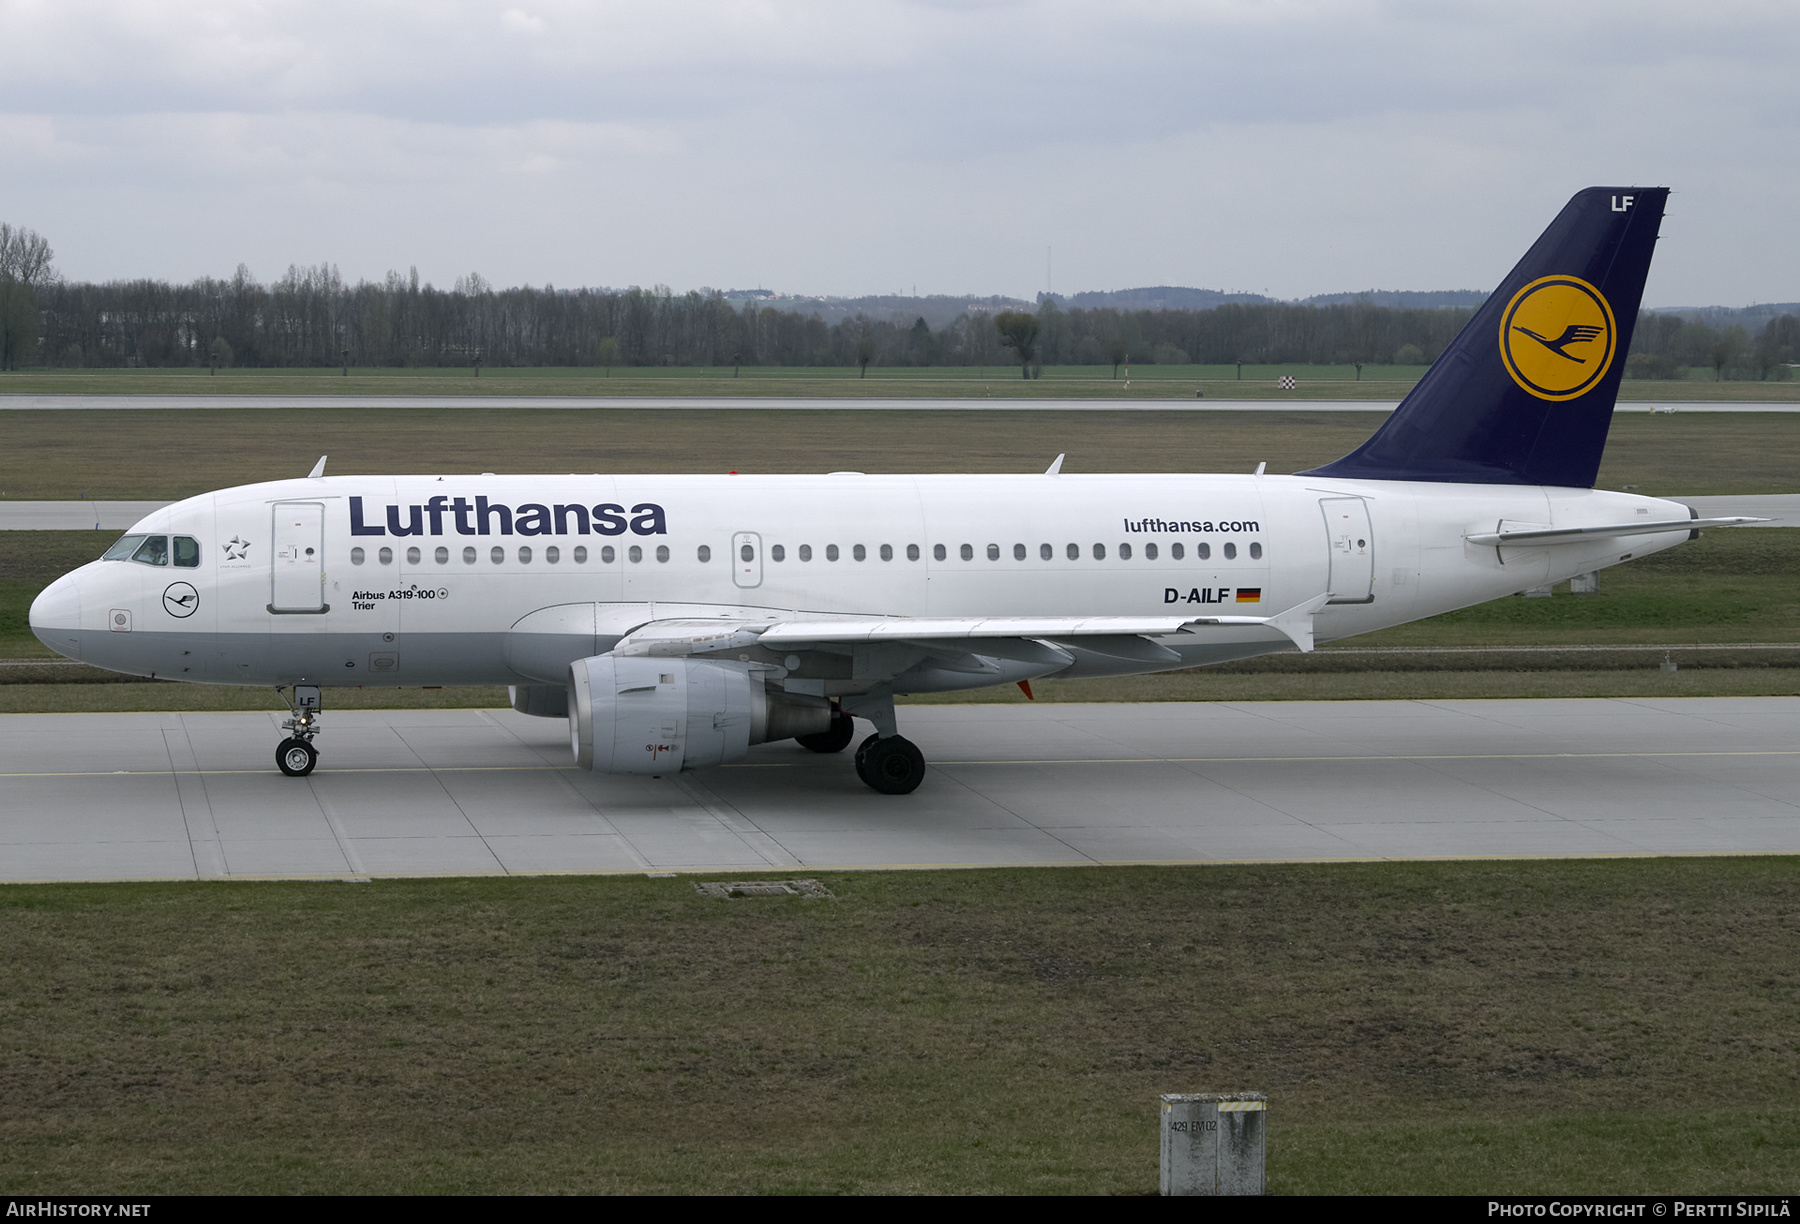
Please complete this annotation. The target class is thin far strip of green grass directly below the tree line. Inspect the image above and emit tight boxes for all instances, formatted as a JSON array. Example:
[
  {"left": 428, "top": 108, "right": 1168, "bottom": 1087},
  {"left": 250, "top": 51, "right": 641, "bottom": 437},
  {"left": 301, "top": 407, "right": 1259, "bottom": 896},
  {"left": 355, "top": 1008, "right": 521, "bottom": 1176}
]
[{"left": 0, "top": 364, "right": 1800, "bottom": 403}]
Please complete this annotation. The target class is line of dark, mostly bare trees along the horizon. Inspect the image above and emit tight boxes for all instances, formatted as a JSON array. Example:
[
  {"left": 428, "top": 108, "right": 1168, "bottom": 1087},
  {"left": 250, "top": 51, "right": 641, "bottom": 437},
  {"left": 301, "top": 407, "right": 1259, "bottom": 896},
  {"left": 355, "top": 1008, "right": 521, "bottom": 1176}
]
[{"left": 0, "top": 225, "right": 1800, "bottom": 378}]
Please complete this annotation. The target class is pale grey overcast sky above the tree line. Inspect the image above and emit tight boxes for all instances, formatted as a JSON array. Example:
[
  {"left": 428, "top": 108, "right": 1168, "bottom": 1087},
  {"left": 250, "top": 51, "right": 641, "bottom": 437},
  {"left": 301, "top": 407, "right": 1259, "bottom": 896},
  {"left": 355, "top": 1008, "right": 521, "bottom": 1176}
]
[{"left": 0, "top": 0, "right": 1800, "bottom": 306}]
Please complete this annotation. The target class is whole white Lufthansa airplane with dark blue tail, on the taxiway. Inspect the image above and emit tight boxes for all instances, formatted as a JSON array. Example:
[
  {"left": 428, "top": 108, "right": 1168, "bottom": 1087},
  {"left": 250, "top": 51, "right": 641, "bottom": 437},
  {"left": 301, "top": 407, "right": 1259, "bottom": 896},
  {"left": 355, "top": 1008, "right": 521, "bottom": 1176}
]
[{"left": 31, "top": 187, "right": 1757, "bottom": 794}]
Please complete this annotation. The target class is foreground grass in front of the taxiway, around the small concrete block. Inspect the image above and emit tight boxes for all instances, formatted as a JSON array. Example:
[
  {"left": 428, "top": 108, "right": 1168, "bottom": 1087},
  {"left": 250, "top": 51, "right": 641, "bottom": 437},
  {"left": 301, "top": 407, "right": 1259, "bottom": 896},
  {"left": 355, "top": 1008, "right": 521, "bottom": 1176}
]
[{"left": 0, "top": 859, "right": 1800, "bottom": 1195}]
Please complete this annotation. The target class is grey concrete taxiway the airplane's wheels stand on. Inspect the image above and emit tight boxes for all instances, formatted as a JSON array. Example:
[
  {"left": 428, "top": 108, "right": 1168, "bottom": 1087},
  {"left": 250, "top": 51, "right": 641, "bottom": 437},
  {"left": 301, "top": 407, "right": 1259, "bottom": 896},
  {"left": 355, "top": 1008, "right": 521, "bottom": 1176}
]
[{"left": 0, "top": 698, "right": 1800, "bottom": 880}]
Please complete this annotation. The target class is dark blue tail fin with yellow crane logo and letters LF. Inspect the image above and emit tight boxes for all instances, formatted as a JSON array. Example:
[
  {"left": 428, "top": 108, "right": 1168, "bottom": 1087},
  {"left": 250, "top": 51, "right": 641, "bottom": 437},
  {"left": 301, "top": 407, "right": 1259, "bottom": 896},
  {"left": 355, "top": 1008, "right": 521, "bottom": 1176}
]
[{"left": 1300, "top": 187, "right": 1669, "bottom": 488}]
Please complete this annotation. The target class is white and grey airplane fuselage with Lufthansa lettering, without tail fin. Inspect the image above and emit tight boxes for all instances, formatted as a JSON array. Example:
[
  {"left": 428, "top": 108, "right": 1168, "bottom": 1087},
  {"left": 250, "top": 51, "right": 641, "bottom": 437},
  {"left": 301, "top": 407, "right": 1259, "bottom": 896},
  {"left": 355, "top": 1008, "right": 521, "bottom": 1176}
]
[{"left": 32, "top": 473, "right": 1688, "bottom": 691}]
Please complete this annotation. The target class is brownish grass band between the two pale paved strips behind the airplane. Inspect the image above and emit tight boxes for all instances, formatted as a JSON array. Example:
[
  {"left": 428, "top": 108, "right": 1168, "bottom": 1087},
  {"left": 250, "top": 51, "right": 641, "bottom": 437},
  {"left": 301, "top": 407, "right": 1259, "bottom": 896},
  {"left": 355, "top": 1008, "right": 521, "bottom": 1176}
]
[{"left": 0, "top": 405, "right": 1800, "bottom": 500}]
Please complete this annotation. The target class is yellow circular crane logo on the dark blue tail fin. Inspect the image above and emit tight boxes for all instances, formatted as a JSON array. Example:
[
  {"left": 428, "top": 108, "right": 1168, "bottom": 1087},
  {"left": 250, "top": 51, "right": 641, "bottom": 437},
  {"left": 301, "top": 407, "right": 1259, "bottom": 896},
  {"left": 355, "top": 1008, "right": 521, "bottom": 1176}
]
[{"left": 1499, "top": 275, "right": 1618, "bottom": 400}]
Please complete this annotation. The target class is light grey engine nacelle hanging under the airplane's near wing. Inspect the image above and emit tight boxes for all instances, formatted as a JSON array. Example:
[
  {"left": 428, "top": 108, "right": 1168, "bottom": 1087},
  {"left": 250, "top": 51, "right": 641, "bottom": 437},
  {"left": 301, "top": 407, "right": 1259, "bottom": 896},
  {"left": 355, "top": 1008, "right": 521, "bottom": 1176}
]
[{"left": 569, "top": 655, "right": 832, "bottom": 774}]
